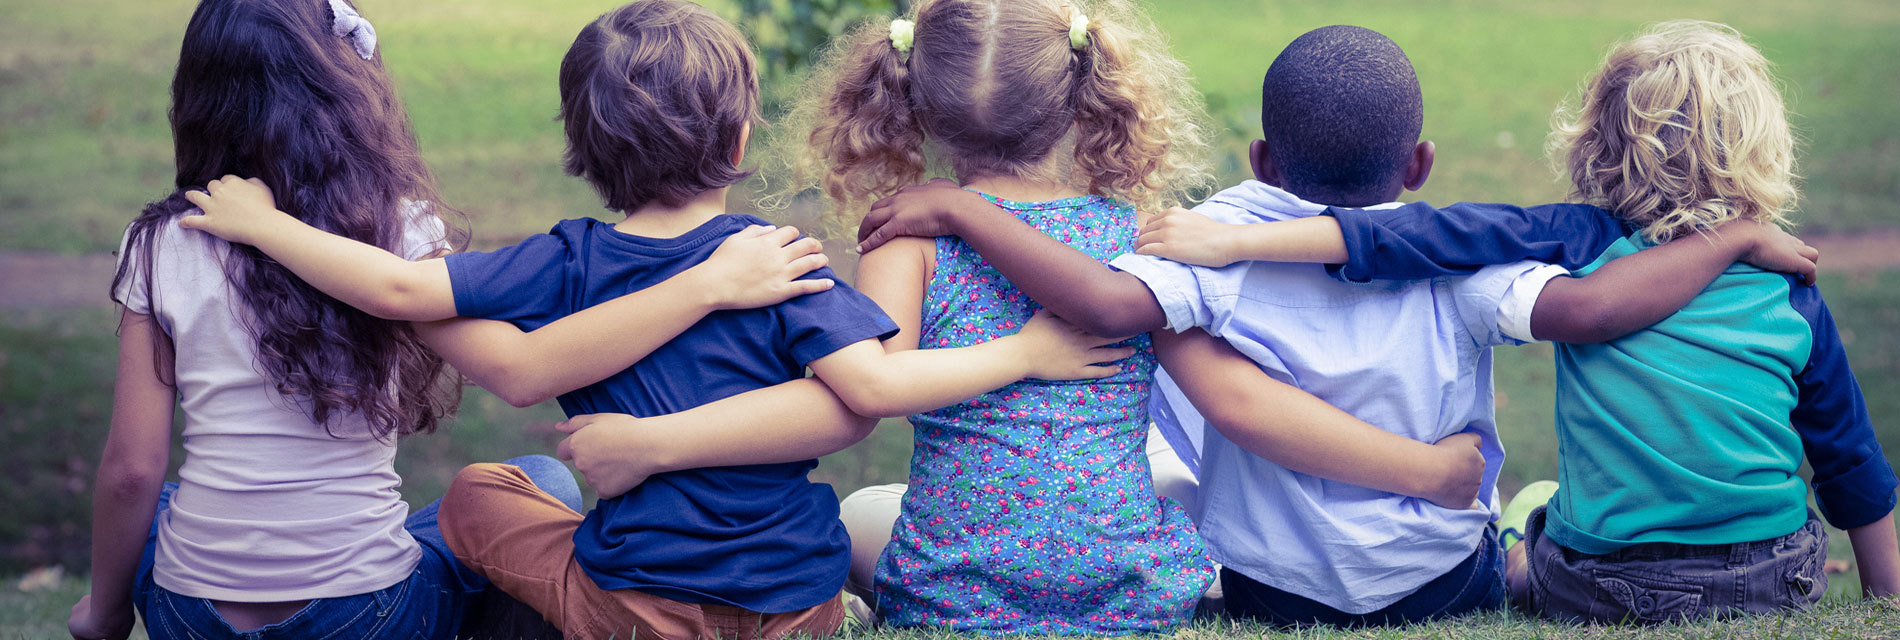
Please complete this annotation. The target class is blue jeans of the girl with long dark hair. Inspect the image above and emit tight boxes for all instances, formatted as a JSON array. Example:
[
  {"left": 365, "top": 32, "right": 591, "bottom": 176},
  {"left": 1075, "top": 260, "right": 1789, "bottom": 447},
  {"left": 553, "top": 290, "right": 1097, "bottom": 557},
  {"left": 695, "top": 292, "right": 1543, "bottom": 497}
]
[{"left": 133, "top": 456, "right": 581, "bottom": 640}]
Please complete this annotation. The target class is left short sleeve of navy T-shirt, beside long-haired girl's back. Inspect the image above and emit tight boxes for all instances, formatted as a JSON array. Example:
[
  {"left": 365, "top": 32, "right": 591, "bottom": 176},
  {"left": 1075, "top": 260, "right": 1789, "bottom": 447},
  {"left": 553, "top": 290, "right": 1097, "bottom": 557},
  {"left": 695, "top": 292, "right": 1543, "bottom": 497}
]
[{"left": 447, "top": 234, "right": 576, "bottom": 324}]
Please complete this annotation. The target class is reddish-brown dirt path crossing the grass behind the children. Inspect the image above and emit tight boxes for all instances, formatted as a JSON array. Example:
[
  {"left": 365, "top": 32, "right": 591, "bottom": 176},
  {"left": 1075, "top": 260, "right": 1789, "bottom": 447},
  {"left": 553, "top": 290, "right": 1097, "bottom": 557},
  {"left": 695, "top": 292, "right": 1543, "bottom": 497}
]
[{"left": 11, "top": 228, "right": 1900, "bottom": 310}]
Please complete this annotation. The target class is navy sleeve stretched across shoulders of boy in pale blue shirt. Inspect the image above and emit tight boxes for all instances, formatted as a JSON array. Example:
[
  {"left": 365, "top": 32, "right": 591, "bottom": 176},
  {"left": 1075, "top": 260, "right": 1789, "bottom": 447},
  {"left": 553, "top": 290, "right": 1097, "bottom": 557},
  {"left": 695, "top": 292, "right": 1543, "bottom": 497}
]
[{"left": 1326, "top": 201, "right": 1628, "bottom": 283}]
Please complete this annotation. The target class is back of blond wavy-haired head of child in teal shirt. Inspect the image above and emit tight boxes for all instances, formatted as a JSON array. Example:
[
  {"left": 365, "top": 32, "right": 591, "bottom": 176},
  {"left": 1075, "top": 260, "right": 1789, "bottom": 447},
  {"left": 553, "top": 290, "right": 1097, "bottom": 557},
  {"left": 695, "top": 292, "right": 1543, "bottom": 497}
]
[{"left": 1550, "top": 21, "right": 1797, "bottom": 241}]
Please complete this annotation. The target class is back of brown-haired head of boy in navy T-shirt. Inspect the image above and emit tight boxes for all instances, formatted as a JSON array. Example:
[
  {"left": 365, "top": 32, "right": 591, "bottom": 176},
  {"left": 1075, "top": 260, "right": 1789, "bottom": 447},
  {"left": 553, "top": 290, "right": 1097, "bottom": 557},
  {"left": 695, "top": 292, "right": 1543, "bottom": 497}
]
[{"left": 561, "top": 0, "right": 758, "bottom": 213}]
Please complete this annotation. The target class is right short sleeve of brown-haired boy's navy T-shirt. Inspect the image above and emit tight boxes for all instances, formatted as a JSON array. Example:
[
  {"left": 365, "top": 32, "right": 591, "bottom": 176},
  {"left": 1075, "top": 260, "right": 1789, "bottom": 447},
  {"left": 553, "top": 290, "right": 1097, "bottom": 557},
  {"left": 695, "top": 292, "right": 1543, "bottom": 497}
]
[{"left": 775, "top": 268, "right": 897, "bottom": 365}]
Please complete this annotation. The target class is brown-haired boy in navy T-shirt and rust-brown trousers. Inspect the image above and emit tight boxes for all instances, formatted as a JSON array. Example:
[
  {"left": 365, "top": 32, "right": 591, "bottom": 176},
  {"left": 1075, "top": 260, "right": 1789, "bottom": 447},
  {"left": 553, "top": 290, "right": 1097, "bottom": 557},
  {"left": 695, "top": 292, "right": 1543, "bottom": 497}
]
[{"left": 186, "top": 0, "right": 1131, "bottom": 638}]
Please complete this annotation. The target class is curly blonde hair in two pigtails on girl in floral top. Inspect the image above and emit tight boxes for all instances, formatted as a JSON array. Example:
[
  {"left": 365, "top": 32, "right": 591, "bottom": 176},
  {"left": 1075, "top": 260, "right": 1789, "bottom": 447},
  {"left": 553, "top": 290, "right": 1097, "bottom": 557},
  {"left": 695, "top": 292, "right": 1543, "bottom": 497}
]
[{"left": 768, "top": 0, "right": 1214, "bottom": 234}]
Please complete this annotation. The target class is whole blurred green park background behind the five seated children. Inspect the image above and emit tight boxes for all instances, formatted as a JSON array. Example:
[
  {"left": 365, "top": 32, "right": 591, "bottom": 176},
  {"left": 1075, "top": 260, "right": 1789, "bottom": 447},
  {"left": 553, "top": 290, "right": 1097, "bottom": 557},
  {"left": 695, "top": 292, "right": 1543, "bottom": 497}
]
[{"left": 0, "top": 0, "right": 1900, "bottom": 622}]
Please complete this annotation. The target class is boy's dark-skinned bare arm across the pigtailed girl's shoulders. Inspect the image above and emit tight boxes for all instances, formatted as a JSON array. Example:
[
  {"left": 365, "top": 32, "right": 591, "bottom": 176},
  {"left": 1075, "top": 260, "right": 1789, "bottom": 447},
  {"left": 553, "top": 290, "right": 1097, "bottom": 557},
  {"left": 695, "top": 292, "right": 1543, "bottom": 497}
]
[{"left": 859, "top": 180, "right": 1167, "bottom": 336}]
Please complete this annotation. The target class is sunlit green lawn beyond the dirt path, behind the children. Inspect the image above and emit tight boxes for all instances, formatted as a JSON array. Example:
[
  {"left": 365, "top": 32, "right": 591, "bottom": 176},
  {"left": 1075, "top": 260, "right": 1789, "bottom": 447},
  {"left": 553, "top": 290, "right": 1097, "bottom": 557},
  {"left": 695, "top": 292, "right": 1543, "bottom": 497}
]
[{"left": 0, "top": 0, "right": 1900, "bottom": 253}]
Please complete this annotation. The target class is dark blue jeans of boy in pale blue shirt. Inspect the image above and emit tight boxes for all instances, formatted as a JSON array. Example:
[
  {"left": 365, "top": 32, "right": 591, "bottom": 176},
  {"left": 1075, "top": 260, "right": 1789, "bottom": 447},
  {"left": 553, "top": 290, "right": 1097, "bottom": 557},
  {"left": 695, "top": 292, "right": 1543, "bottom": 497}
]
[{"left": 1220, "top": 528, "right": 1507, "bottom": 627}]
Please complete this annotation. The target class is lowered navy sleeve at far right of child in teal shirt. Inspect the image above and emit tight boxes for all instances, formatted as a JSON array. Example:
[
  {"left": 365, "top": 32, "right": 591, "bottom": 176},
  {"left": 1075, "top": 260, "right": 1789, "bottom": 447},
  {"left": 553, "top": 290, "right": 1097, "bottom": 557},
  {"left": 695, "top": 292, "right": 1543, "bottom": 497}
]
[{"left": 1788, "top": 283, "right": 1900, "bottom": 530}]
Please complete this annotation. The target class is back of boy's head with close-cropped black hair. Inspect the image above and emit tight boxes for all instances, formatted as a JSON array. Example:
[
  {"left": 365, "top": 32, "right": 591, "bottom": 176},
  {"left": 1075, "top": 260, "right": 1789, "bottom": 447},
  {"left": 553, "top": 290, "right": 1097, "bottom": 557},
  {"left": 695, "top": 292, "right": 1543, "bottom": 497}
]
[{"left": 1260, "top": 25, "right": 1425, "bottom": 203}]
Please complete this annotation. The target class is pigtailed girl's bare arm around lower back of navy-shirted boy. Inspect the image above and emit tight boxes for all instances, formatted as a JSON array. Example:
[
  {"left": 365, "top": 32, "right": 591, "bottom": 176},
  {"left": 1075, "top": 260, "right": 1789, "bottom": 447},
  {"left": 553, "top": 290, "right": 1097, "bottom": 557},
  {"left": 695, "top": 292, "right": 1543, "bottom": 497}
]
[{"left": 557, "top": 378, "right": 878, "bottom": 498}]
